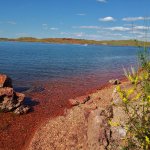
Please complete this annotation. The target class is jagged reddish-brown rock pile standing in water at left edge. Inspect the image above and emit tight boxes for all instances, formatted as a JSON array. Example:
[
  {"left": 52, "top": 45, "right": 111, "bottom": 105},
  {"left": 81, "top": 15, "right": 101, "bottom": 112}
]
[{"left": 0, "top": 74, "right": 30, "bottom": 114}]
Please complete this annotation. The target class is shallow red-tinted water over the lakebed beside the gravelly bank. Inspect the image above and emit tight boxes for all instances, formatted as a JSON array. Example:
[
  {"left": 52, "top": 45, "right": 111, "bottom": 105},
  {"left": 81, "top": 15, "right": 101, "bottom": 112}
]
[{"left": 0, "top": 74, "right": 125, "bottom": 150}]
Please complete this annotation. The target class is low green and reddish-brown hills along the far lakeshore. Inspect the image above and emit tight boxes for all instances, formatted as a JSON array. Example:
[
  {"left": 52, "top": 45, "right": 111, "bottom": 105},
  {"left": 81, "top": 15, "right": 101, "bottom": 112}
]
[{"left": 0, "top": 37, "right": 150, "bottom": 47}]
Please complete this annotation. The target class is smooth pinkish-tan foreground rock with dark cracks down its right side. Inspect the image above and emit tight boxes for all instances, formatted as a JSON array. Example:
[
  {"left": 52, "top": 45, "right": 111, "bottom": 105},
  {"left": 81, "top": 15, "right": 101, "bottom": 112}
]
[{"left": 87, "top": 107, "right": 113, "bottom": 150}]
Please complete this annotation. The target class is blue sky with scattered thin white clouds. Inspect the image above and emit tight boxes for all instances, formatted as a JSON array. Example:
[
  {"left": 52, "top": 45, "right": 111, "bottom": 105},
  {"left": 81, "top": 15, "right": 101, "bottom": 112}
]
[{"left": 0, "top": 0, "right": 150, "bottom": 40}]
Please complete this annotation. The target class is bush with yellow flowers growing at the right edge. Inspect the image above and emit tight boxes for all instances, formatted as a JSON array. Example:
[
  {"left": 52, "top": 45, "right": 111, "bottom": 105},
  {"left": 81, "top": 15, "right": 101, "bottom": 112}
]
[{"left": 117, "top": 49, "right": 150, "bottom": 150}]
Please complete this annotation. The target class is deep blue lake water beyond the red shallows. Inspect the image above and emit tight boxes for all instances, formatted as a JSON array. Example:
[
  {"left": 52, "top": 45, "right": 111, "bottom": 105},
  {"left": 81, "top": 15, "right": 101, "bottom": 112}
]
[{"left": 0, "top": 42, "right": 138, "bottom": 88}]
